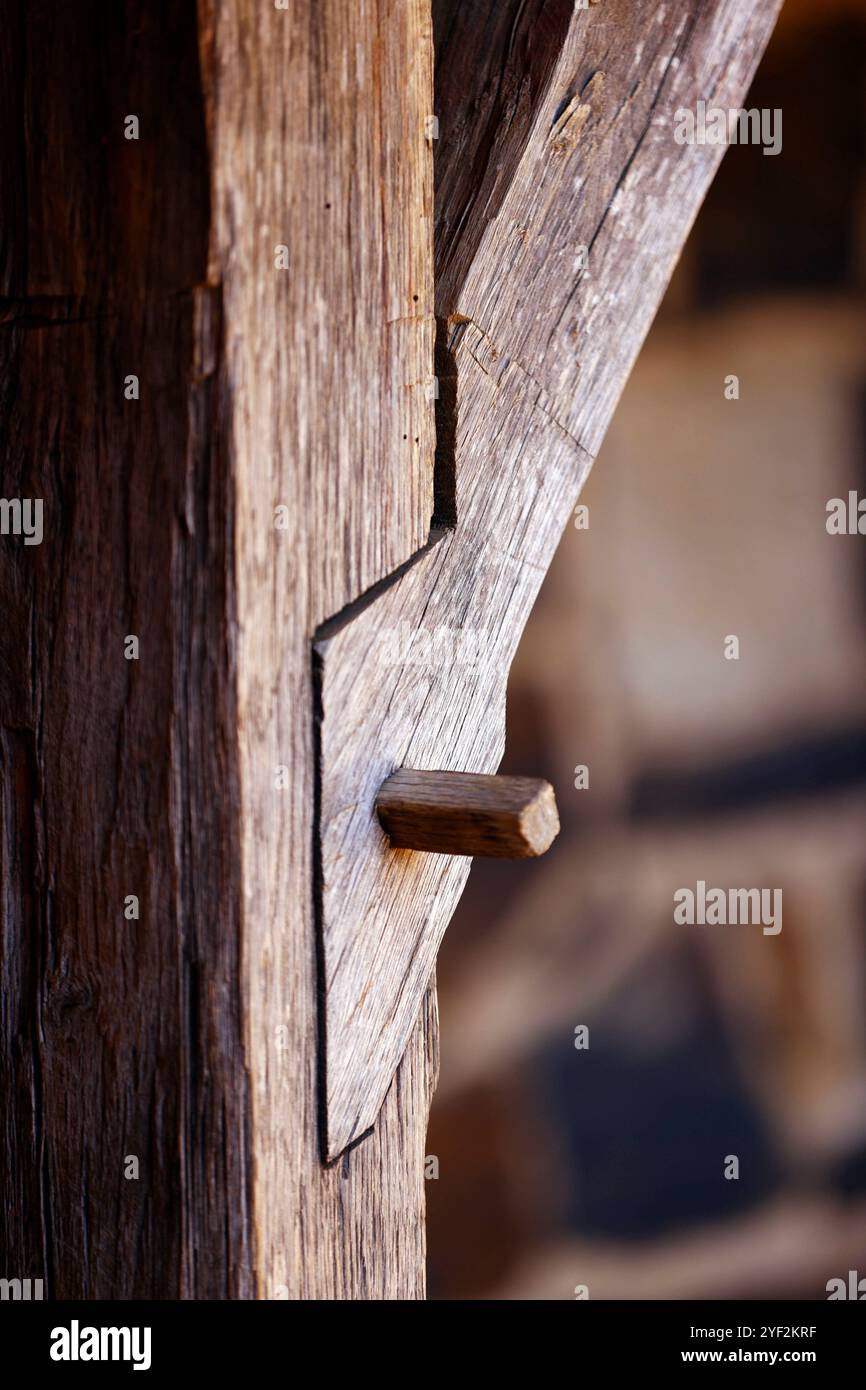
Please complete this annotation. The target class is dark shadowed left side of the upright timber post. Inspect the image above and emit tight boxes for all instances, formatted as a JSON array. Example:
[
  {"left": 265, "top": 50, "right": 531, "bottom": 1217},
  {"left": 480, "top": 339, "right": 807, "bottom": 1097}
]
[{"left": 0, "top": 3, "right": 253, "bottom": 1298}]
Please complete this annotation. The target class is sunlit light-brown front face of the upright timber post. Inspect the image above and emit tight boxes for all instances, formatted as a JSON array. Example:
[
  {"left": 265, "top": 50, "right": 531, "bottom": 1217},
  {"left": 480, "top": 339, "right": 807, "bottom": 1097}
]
[{"left": 204, "top": 0, "right": 435, "bottom": 1298}]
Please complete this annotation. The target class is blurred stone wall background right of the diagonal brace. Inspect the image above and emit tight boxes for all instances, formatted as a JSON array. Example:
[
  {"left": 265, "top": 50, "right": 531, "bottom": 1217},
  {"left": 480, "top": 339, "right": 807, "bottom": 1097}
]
[{"left": 427, "top": 0, "right": 866, "bottom": 1300}]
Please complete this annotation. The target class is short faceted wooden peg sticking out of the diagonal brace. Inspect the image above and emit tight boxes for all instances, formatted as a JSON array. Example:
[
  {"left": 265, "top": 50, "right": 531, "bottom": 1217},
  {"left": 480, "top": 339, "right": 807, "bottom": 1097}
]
[{"left": 375, "top": 767, "right": 559, "bottom": 859}]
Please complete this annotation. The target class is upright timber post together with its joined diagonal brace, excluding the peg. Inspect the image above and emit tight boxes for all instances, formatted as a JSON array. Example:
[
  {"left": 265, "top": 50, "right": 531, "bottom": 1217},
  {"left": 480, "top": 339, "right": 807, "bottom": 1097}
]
[{"left": 0, "top": 0, "right": 777, "bottom": 1298}]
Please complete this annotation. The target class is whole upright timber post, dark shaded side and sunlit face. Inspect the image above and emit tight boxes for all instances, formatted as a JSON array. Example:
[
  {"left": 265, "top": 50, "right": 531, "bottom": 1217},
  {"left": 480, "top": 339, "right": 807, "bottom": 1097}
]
[{"left": 0, "top": 0, "right": 435, "bottom": 1298}]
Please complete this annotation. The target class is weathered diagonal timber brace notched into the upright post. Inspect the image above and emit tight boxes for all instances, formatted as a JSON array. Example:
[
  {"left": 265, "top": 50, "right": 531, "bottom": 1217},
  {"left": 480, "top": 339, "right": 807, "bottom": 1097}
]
[{"left": 318, "top": 0, "right": 778, "bottom": 1155}]
